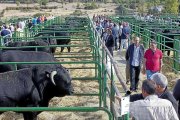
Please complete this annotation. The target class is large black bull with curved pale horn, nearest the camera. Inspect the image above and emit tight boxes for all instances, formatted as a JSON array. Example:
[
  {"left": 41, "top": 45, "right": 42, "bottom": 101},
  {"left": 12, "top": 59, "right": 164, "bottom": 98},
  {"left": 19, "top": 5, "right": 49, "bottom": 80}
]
[{"left": 0, "top": 68, "right": 71, "bottom": 120}]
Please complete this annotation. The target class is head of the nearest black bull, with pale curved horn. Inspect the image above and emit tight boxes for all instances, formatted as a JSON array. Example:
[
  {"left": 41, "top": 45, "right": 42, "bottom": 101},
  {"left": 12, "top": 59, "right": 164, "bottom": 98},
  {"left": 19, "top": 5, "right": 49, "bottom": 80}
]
[{"left": 47, "top": 66, "right": 74, "bottom": 96}]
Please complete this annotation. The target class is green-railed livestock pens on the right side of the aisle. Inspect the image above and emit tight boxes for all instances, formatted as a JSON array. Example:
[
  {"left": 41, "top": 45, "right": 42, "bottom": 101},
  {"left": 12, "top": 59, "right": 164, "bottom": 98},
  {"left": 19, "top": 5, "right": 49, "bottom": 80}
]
[{"left": 110, "top": 16, "right": 180, "bottom": 74}]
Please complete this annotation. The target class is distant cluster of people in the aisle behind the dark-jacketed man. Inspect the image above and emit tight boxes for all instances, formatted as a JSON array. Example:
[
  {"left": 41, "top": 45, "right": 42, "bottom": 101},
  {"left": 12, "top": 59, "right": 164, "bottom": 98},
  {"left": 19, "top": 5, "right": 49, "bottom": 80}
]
[{"left": 93, "top": 15, "right": 131, "bottom": 56}]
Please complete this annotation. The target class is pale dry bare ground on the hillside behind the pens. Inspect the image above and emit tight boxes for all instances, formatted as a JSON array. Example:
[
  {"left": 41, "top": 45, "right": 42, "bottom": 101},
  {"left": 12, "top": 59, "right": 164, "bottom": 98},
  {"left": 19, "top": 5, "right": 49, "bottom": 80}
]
[{"left": 0, "top": 2, "right": 117, "bottom": 18}]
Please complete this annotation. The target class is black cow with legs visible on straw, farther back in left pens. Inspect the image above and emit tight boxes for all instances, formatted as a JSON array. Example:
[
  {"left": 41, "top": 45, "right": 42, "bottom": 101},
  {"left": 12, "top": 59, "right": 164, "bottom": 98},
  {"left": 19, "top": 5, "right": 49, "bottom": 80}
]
[{"left": 34, "top": 26, "right": 71, "bottom": 52}]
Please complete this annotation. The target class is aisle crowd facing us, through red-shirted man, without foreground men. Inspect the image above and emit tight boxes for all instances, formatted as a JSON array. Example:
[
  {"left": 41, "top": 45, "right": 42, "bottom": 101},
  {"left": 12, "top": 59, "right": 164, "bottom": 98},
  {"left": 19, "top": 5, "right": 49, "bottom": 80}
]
[{"left": 93, "top": 15, "right": 163, "bottom": 91}]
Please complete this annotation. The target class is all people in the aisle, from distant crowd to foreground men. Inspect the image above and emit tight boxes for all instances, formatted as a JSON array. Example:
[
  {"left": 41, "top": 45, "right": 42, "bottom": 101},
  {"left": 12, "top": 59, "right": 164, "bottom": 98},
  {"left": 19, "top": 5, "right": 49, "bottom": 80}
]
[{"left": 93, "top": 15, "right": 180, "bottom": 120}]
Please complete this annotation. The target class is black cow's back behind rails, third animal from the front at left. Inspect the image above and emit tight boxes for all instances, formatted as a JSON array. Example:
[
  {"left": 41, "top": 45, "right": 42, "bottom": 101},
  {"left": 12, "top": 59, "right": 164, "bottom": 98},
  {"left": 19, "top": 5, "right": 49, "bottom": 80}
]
[{"left": 5, "top": 40, "right": 57, "bottom": 53}]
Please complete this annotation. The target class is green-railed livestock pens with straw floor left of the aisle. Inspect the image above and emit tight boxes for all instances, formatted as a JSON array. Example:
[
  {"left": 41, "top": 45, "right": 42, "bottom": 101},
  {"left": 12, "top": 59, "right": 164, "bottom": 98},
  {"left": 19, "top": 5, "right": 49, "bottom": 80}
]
[{"left": 0, "top": 16, "right": 129, "bottom": 120}]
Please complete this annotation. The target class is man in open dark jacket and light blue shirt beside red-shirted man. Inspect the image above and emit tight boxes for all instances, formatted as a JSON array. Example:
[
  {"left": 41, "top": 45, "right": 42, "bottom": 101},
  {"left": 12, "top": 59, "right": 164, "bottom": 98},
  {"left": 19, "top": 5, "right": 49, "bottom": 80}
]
[{"left": 126, "top": 37, "right": 144, "bottom": 91}]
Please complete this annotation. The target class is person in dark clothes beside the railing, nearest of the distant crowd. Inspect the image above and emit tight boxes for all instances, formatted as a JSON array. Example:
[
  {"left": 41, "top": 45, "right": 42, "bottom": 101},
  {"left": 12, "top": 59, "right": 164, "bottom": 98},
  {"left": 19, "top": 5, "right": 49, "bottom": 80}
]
[{"left": 105, "top": 29, "right": 114, "bottom": 56}]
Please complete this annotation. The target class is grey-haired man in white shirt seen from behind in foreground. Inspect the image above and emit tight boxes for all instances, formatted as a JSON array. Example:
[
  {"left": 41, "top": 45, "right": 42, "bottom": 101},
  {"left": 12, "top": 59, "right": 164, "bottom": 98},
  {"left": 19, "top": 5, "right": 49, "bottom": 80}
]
[{"left": 129, "top": 80, "right": 179, "bottom": 120}]
